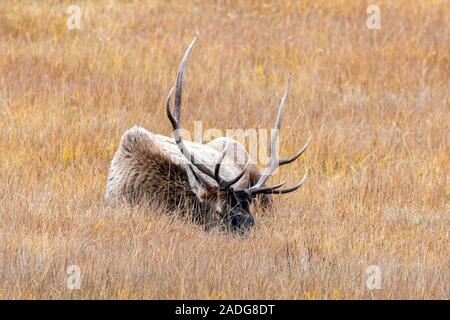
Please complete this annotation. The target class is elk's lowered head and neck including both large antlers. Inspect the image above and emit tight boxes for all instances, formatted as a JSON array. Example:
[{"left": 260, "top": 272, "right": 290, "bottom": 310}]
[{"left": 166, "top": 38, "right": 310, "bottom": 232}]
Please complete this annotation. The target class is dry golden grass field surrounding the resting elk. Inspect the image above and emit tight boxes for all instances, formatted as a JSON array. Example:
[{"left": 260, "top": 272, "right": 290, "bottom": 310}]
[{"left": 0, "top": 0, "right": 450, "bottom": 299}]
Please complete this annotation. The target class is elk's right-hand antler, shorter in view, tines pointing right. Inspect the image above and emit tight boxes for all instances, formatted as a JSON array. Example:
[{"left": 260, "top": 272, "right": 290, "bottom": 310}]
[{"left": 246, "top": 75, "right": 311, "bottom": 195}]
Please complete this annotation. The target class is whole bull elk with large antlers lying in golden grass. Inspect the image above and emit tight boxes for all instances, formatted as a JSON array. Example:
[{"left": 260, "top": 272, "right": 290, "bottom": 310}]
[{"left": 106, "top": 38, "right": 310, "bottom": 232}]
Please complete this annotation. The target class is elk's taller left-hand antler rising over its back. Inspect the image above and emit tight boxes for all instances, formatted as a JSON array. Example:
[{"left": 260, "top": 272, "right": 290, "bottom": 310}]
[{"left": 166, "top": 37, "right": 250, "bottom": 189}]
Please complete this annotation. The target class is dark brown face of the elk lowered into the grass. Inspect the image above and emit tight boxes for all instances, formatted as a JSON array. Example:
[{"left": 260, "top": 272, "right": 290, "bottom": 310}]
[{"left": 219, "top": 188, "right": 255, "bottom": 233}]
